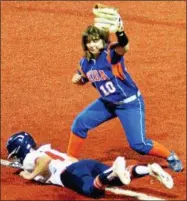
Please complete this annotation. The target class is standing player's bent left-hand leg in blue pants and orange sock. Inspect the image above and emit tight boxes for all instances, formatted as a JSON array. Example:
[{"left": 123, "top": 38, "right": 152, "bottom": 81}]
[{"left": 67, "top": 98, "right": 115, "bottom": 157}]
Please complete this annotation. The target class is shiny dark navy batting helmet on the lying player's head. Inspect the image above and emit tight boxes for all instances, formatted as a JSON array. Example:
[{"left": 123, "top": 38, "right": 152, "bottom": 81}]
[{"left": 6, "top": 131, "right": 36, "bottom": 163}]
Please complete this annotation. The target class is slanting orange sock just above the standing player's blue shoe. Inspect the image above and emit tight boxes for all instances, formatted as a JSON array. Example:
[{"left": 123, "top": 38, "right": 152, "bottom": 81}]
[{"left": 148, "top": 141, "right": 171, "bottom": 159}]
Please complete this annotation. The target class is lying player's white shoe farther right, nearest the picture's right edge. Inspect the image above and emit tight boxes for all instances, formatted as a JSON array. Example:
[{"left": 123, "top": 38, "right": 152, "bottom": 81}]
[{"left": 148, "top": 163, "right": 174, "bottom": 189}]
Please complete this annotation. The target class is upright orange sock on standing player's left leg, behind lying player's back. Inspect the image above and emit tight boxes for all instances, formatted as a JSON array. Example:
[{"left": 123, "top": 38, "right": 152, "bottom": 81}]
[{"left": 67, "top": 132, "right": 84, "bottom": 158}]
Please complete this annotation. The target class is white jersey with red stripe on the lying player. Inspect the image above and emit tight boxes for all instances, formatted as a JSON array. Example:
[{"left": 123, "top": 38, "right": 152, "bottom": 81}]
[{"left": 23, "top": 144, "right": 72, "bottom": 186}]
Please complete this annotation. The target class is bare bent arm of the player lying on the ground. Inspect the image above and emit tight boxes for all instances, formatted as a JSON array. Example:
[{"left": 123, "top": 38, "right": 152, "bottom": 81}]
[{"left": 20, "top": 155, "right": 52, "bottom": 180}]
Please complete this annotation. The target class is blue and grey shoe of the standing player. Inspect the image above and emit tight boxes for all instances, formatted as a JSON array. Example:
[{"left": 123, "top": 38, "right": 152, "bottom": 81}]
[{"left": 167, "top": 151, "right": 183, "bottom": 172}]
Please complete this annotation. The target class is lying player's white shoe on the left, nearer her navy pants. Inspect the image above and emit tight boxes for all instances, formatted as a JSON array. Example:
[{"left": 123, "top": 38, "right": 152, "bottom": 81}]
[{"left": 112, "top": 156, "right": 131, "bottom": 185}]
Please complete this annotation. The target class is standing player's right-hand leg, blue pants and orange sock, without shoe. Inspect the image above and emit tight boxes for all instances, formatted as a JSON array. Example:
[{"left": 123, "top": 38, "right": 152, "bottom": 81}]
[{"left": 116, "top": 96, "right": 170, "bottom": 155}]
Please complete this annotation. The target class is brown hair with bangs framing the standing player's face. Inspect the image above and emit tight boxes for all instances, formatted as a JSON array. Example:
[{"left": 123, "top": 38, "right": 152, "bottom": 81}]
[{"left": 82, "top": 25, "right": 109, "bottom": 60}]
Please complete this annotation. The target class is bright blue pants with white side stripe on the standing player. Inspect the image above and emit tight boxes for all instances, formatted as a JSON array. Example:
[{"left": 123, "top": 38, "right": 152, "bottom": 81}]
[{"left": 72, "top": 96, "right": 153, "bottom": 154}]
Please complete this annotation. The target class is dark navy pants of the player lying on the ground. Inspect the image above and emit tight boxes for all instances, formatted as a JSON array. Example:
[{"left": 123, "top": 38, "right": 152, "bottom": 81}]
[{"left": 61, "top": 159, "right": 123, "bottom": 198}]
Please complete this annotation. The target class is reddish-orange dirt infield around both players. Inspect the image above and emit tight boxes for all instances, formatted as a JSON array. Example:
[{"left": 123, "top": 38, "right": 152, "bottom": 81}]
[{"left": 1, "top": 1, "right": 186, "bottom": 200}]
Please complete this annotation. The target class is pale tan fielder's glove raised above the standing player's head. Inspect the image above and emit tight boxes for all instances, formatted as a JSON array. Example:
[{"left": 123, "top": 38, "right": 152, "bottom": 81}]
[{"left": 93, "top": 4, "right": 123, "bottom": 33}]
